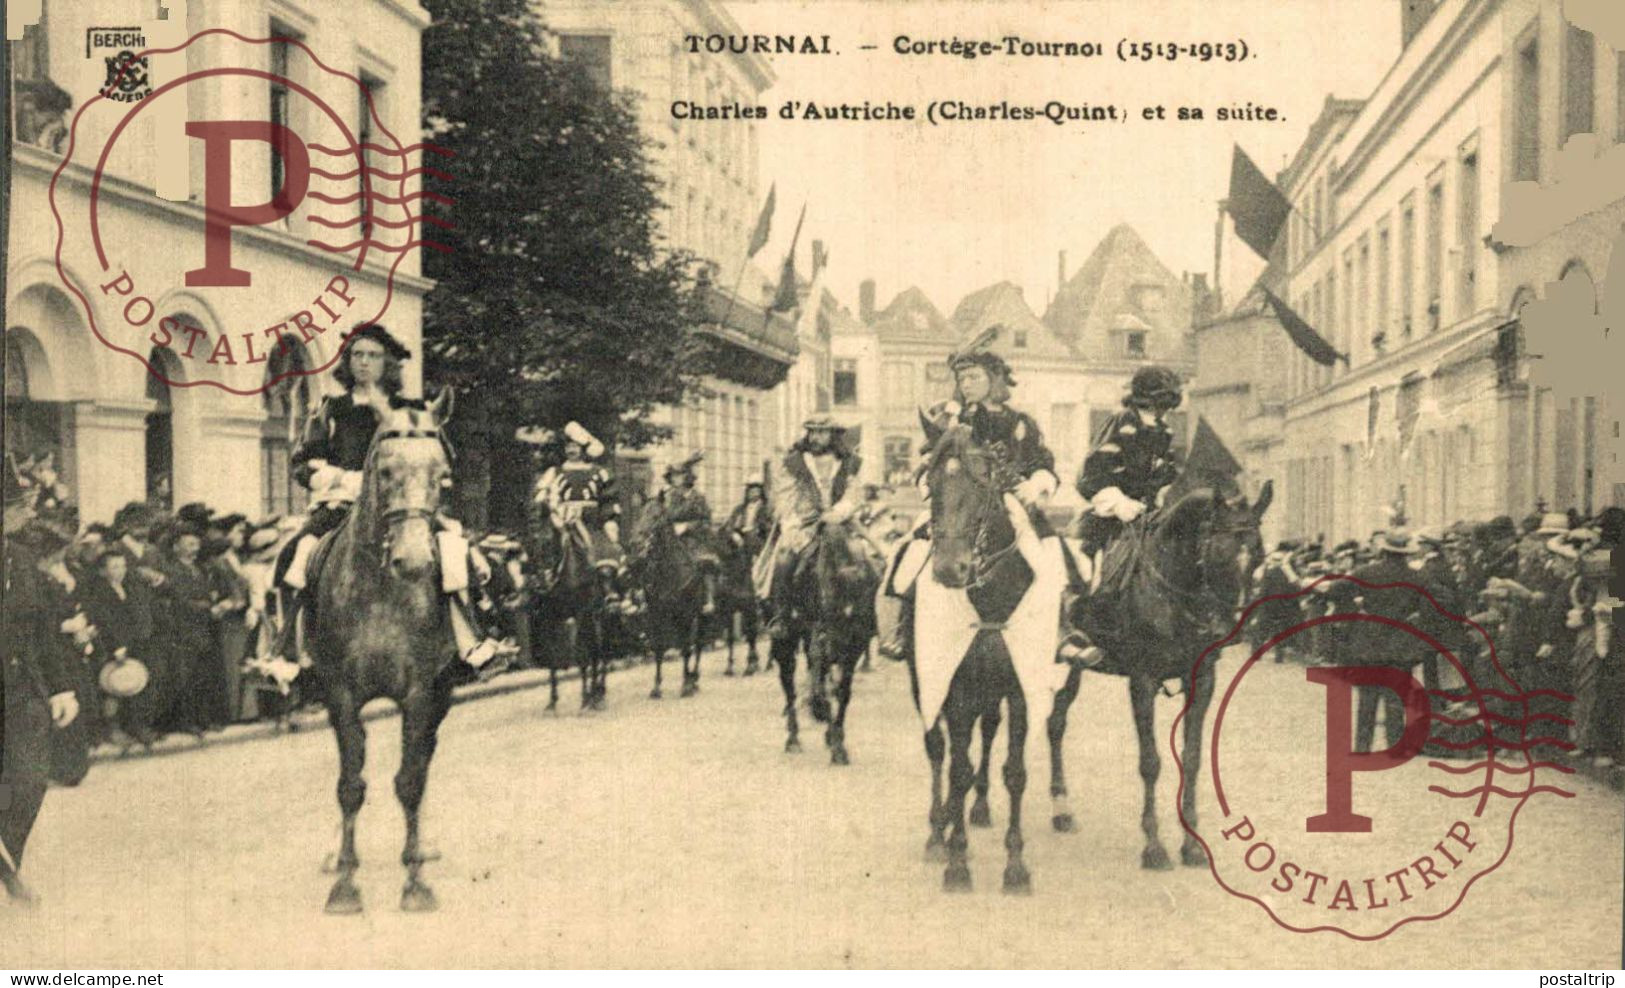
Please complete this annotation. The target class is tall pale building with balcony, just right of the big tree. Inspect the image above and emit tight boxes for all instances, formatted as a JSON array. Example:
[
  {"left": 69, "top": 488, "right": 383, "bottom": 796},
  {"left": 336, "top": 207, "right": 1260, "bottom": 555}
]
[{"left": 536, "top": 0, "right": 798, "bottom": 512}]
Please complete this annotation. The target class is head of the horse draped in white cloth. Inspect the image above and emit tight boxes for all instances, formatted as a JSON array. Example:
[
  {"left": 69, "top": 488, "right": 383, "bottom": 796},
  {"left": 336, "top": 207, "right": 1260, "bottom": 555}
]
[{"left": 920, "top": 414, "right": 1014, "bottom": 588}]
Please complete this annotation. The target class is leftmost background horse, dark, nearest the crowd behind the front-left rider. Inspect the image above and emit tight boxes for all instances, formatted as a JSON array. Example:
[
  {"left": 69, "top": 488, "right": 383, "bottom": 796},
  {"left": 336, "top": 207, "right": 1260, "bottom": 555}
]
[{"left": 530, "top": 504, "right": 613, "bottom": 712}]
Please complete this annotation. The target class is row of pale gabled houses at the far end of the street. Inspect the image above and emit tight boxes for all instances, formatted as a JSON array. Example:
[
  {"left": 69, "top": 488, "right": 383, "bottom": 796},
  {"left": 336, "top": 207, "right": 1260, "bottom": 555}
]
[{"left": 832, "top": 224, "right": 1207, "bottom": 507}]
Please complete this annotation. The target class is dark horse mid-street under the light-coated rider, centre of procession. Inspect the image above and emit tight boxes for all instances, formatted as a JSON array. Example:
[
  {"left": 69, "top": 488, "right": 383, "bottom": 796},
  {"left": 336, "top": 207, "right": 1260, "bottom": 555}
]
[{"left": 772, "top": 522, "right": 879, "bottom": 765}]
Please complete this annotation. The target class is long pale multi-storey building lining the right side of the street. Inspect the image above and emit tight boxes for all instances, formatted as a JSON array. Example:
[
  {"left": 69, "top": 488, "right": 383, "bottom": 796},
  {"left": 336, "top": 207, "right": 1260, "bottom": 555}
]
[{"left": 1196, "top": 0, "right": 1625, "bottom": 540}]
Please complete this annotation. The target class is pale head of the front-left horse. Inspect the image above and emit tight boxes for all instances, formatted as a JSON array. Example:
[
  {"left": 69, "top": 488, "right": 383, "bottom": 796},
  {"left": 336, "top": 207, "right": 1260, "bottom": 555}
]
[{"left": 362, "top": 388, "right": 452, "bottom": 577}]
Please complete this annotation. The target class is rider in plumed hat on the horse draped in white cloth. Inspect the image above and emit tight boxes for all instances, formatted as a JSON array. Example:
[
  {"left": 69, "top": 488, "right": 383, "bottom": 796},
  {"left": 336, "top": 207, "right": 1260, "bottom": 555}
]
[{"left": 878, "top": 325, "right": 1066, "bottom": 658}]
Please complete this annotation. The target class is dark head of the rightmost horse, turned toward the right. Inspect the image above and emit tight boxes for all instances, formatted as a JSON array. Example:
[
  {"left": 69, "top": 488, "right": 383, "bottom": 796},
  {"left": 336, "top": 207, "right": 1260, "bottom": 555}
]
[{"left": 1164, "top": 481, "right": 1274, "bottom": 609}]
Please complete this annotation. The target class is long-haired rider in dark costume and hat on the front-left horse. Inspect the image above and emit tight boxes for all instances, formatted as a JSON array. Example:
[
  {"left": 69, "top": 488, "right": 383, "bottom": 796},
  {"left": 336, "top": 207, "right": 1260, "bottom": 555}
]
[{"left": 273, "top": 323, "right": 507, "bottom": 679}]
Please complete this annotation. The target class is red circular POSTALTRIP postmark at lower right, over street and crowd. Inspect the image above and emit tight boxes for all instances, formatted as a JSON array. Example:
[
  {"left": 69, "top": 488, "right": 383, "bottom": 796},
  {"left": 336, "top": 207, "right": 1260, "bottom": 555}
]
[{"left": 1173, "top": 575, "right": 1573, "bottom": 939}]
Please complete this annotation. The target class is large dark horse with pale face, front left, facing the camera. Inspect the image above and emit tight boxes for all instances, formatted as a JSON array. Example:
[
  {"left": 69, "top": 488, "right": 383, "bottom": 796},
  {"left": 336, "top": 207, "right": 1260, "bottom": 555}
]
[{"left": 306, "top": 388, "right": 466, "bottom": 913}]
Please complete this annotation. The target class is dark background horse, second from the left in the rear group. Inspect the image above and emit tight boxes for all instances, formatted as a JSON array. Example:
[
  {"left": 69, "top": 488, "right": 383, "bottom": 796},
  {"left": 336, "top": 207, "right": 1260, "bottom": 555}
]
[{"left": 627, "top": 499, "right": 705, "bottom": 700}]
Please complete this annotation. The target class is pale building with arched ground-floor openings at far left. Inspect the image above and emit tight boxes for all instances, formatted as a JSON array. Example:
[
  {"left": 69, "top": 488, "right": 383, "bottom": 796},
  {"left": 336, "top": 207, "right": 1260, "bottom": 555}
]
[{"left": 5, "top": 0, "right": 429, "bottom": 522}]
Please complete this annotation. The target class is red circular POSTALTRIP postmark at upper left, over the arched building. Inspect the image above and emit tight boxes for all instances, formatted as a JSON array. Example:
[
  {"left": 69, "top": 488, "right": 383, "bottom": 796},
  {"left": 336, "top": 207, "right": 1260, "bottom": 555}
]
[{"left": 50, "top": 28, "right": 453, "bottom": 395}]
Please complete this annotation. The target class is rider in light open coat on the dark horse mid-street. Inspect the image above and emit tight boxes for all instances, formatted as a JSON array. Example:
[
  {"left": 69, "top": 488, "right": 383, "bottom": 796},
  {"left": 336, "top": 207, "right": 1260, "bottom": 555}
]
[{"left": 759, "top": 416, "right": 861, "bottom": 639}]
